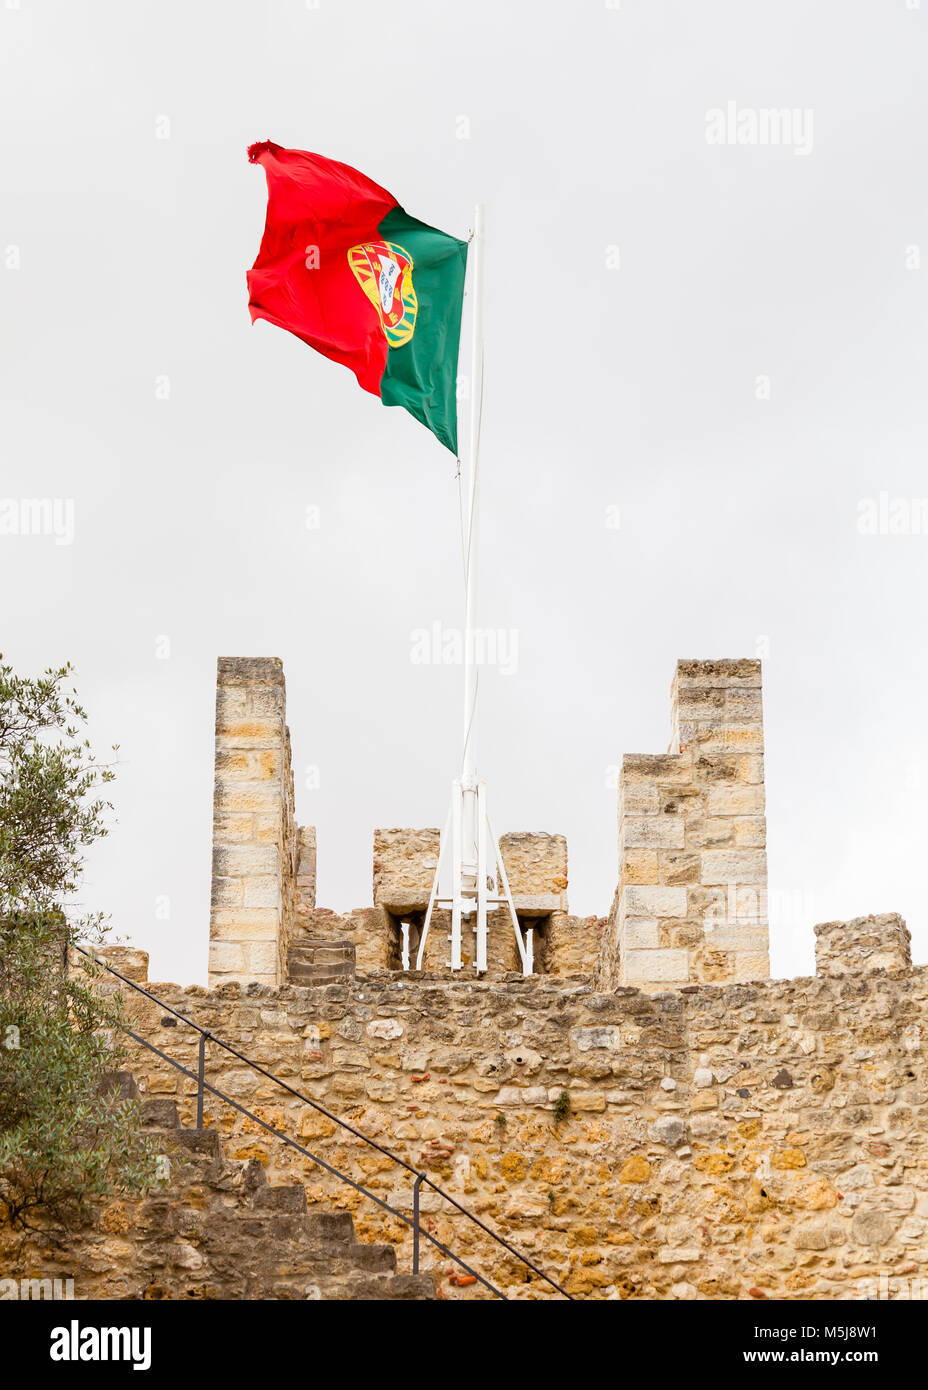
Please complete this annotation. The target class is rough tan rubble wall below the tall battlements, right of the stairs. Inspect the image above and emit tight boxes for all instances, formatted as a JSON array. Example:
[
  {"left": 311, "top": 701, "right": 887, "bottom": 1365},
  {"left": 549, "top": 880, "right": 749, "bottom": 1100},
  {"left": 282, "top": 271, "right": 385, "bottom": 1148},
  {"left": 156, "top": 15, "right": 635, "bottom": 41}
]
[{"left": 110, "top": 916, "right": 928, "bottom": 1298}]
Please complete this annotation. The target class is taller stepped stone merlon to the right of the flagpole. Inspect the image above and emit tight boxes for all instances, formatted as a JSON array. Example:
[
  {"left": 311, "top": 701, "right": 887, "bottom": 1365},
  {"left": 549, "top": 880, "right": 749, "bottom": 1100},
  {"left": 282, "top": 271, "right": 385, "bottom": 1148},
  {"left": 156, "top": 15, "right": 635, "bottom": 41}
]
[{"left": 597, "top": 660, "right": 770, "bottom": 990}]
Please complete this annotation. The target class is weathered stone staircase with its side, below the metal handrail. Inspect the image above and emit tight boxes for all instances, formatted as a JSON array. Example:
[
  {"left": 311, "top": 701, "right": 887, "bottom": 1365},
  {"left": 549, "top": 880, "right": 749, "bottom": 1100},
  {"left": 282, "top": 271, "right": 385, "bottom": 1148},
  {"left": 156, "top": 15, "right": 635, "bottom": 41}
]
[{"left": 0, "top": 1072, "right": 438, "bottom": 1301}]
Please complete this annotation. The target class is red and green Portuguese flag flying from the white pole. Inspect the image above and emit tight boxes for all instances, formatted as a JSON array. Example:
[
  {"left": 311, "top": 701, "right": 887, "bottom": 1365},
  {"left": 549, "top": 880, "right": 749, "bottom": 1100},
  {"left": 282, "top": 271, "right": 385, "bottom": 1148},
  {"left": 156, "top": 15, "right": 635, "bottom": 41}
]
[{"left": 247, "top": 140, "right": 467, "bottom": 453}]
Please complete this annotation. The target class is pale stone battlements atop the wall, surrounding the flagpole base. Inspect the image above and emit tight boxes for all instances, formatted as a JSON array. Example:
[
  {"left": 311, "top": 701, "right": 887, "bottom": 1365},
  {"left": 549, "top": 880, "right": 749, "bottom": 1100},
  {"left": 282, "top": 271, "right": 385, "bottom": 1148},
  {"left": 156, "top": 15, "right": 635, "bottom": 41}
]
[{"left": 210, "top": 657, "right": 770, "bottom": 991}]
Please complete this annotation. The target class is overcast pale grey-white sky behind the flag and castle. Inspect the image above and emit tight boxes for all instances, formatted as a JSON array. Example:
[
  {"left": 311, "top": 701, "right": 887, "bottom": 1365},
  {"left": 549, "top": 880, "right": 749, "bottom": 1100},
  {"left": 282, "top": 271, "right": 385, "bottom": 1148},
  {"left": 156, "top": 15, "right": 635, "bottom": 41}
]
[{"left": 0, "top": 0, "right": 928, "bottom": 981}]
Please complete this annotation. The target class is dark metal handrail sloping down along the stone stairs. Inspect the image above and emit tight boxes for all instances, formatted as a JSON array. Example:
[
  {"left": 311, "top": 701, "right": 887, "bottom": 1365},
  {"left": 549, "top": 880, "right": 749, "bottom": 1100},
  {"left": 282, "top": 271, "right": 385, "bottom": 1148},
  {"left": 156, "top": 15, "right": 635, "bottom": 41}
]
[{"left": 72, "top": 942, "right": 574, "bottom": 1302}]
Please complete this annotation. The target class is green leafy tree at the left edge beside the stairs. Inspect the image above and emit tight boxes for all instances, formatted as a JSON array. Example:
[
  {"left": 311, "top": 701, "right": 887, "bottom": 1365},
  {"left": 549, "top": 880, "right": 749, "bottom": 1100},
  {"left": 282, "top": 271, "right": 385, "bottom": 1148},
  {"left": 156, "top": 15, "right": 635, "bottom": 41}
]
[{"left": 0, "top": 662, "right": 154, "bottom": 1227}]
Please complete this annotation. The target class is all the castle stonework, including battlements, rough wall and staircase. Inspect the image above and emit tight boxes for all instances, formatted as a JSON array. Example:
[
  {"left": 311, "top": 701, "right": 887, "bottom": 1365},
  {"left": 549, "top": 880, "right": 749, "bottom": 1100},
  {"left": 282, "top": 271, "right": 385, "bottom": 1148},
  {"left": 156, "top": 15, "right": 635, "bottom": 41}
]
[{"left": 9, "top": 659, "right": 928, "bottom": 1300}]
